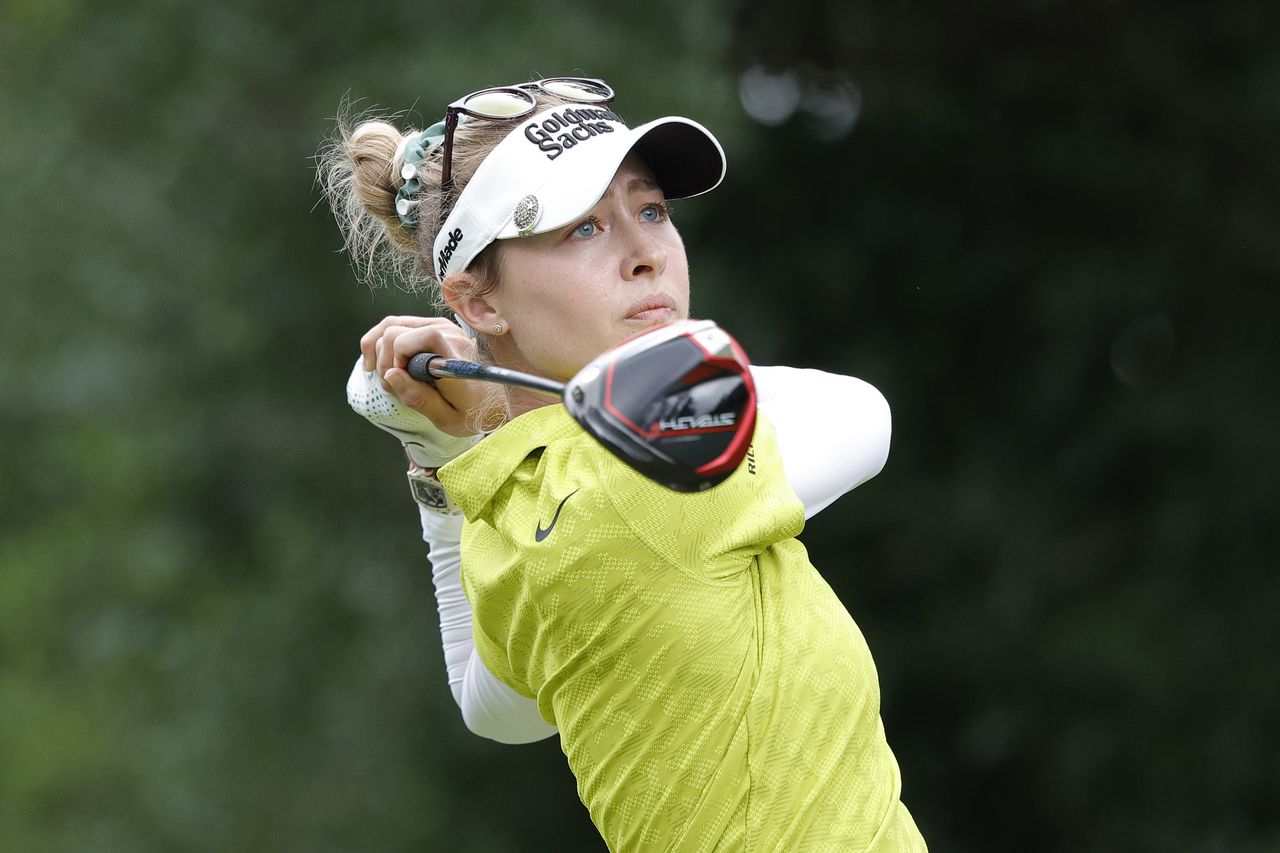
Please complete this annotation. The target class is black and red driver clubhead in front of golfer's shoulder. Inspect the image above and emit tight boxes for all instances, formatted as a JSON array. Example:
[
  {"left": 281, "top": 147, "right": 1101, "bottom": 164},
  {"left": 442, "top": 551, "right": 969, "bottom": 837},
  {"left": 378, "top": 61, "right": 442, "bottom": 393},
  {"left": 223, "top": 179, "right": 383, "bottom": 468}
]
[{"left": 564, "top": 320, "right": 755, "bottom": 492}]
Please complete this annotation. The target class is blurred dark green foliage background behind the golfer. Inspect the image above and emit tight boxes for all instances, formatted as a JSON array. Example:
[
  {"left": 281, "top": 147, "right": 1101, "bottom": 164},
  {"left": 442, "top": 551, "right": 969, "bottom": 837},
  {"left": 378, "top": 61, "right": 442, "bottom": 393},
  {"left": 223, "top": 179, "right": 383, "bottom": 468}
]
[{"left": 0, "top": 0, "right": 1280, "bottom": 852}]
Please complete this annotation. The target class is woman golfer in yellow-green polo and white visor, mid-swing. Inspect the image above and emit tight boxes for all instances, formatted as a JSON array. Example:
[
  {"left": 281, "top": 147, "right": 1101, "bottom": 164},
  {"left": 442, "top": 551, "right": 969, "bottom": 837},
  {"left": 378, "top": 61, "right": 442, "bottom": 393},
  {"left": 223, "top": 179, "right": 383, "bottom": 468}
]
[{"left": 324, "top": 78, "right": 925, "bottom": 852}]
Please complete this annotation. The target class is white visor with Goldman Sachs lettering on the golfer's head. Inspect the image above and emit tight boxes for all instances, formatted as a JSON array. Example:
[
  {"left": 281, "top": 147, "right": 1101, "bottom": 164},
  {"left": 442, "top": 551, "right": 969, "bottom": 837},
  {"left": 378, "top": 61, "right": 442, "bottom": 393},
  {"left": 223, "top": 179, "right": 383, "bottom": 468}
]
[{"left": 433, "top": 104, "right": 724, "bottom": 279}]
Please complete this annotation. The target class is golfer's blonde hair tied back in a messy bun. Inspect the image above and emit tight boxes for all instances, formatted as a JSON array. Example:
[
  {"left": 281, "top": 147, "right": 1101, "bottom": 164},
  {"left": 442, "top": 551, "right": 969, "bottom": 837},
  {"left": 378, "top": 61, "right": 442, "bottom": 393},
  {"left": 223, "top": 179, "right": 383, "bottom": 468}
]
[{"left": 317, "top": 92, "right": 581, "bottom": 310}]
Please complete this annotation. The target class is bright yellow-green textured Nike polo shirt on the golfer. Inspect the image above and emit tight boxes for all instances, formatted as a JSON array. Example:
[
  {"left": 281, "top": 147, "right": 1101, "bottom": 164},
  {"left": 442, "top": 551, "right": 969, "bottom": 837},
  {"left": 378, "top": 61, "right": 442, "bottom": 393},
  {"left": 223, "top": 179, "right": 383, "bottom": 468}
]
[{"left": 440, "top": 405, "right": 925, "bottom": 850}]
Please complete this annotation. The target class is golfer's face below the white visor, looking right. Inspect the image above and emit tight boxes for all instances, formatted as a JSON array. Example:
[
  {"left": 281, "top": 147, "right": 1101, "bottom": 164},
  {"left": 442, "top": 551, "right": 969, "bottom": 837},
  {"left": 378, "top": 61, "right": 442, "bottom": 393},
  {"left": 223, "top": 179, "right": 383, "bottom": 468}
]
[{"left": 486, "top": 155, "right": 689, "bottom": 380}]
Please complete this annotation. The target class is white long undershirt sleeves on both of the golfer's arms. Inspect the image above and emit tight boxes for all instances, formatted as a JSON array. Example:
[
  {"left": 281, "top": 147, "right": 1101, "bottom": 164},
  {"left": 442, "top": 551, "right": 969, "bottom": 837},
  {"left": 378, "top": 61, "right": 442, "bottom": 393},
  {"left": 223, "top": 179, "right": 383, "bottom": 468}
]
[{"left": 394, "top": 366, "right": 891, "bottom": 743}]
